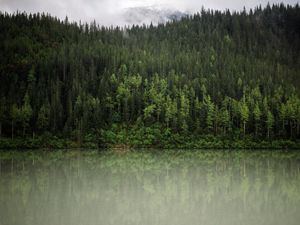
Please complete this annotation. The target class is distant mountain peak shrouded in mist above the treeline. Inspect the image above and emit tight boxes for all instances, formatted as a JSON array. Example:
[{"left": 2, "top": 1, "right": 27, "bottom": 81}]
[{"left": 122, "top": 6, "right": 187, "bottom": 25}]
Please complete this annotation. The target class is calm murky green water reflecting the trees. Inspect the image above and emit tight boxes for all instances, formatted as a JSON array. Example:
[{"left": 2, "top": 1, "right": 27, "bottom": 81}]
[{"left": 0, "top": 150, "right": 300, "bottom": 225}]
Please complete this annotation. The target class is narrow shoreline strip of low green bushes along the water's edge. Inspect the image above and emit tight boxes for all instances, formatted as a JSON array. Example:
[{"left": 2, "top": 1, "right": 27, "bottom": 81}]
[{"left": 0, "top": 136, "right": 300, "bottom": 151}]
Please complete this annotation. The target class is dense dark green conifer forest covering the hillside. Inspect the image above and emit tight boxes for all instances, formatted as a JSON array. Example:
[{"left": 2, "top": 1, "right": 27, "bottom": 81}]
[{"left": 0, "top": 4, "right": 300, "bottom": 148}]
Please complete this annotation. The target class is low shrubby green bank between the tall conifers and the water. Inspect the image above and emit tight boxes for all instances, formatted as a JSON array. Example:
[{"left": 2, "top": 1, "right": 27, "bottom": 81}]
[{"left": 0, "top": 132, "right": 300, "bottom": 150}]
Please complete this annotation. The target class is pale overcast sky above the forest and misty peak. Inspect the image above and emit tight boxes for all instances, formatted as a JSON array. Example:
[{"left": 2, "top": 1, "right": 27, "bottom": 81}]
[{"left": 0, "top": 0, "right": 299, "bottom": 25}]
